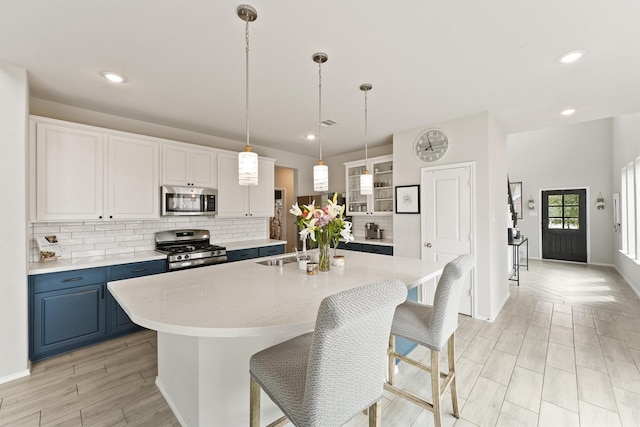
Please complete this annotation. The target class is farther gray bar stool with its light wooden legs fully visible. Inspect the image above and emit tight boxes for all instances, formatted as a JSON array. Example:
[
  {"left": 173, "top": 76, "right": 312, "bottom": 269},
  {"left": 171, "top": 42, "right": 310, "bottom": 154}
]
[{"left": 385, "top": 255, "right": 474, "bottom": 427}]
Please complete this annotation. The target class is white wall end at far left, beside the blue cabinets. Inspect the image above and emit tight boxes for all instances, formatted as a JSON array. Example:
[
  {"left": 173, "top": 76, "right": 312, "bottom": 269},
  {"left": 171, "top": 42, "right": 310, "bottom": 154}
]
[{"left": 0, "top": 63, "right": 29, "bottom": 383}]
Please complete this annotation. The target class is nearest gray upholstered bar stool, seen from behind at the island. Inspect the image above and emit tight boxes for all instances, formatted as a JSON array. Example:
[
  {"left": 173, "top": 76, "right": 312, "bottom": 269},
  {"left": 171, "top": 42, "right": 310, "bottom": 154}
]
[{"left": 249, "top": 281, "right": 407, "bottom": 427}]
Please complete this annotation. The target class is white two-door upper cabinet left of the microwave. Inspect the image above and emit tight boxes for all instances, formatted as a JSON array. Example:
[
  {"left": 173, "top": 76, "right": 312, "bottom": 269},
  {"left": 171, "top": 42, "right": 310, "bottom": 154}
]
[{"left": 35, "top": 120, "right": 160, "bottom": 221}]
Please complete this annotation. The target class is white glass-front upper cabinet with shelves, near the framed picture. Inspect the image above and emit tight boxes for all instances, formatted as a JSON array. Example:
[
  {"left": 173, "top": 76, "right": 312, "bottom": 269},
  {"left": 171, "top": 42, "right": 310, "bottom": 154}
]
[{"left": 344, "top": 155, "right": 393, "bottom": 216}]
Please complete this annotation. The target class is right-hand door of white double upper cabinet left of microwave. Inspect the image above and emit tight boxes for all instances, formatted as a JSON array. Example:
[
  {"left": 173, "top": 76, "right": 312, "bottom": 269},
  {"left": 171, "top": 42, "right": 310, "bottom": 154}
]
[{"left": 107, "top": 136, "right": 160, "bottom": 219}]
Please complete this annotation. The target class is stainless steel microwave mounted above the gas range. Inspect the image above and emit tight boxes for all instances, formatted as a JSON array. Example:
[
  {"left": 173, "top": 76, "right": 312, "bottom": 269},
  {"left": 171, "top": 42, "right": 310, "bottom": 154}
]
[{"left": 161, "top": 185, "right": 218, "bottom": 215}]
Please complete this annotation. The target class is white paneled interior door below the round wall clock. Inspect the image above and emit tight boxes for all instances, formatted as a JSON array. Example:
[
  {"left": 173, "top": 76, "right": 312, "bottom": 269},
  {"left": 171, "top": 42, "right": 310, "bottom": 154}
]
[{"left": 421, "top": 166, "right": 473, "bottom": 316}]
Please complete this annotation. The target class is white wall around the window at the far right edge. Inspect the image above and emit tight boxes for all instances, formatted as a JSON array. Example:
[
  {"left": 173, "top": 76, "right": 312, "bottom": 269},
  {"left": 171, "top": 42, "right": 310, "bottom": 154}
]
[{"left": 607, "top": 113, "right": 640, "bottom": 295}]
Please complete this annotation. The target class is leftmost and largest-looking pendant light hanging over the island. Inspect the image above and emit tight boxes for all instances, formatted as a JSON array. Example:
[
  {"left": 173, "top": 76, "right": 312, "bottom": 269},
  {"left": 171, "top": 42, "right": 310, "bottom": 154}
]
[{"left": 236, "top": 4, "right": 258, "bottom": 185}]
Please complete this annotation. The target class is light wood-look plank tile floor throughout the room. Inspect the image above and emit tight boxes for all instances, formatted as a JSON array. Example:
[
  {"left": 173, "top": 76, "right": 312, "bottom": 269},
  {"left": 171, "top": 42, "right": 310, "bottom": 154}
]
[{"left": 0, "top": 260, "right": 640, "bottom": 427}]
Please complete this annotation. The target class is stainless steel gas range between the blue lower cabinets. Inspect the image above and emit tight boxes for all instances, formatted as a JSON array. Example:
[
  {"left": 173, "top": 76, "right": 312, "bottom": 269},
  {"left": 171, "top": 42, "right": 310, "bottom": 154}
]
[{"left": 156, "top": 229, "right": 227, "bottom": 271}]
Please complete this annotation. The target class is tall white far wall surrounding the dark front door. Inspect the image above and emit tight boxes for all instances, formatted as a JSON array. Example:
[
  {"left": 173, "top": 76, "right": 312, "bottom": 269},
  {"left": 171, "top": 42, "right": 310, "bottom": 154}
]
[{"left": 507, "top": 119, "right": 619, "bottom": 265}]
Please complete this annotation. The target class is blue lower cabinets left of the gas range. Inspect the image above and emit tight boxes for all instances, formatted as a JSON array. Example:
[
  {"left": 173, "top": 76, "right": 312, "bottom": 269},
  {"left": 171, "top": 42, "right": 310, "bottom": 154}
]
[{"left": 29, "top": 260, "right": 166, "bottom": 362}]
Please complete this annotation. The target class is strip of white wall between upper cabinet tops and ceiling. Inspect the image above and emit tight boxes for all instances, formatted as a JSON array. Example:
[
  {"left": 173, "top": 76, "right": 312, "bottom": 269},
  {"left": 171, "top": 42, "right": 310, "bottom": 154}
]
[{"left": 30, "top": 98, "right": 318, "bottom": 194}]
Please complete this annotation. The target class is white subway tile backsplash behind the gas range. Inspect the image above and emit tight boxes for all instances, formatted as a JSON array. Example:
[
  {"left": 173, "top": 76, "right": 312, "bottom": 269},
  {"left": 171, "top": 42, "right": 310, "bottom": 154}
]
[{"left": 29, "top": 216, "right": 269, "bottom": 262}]
